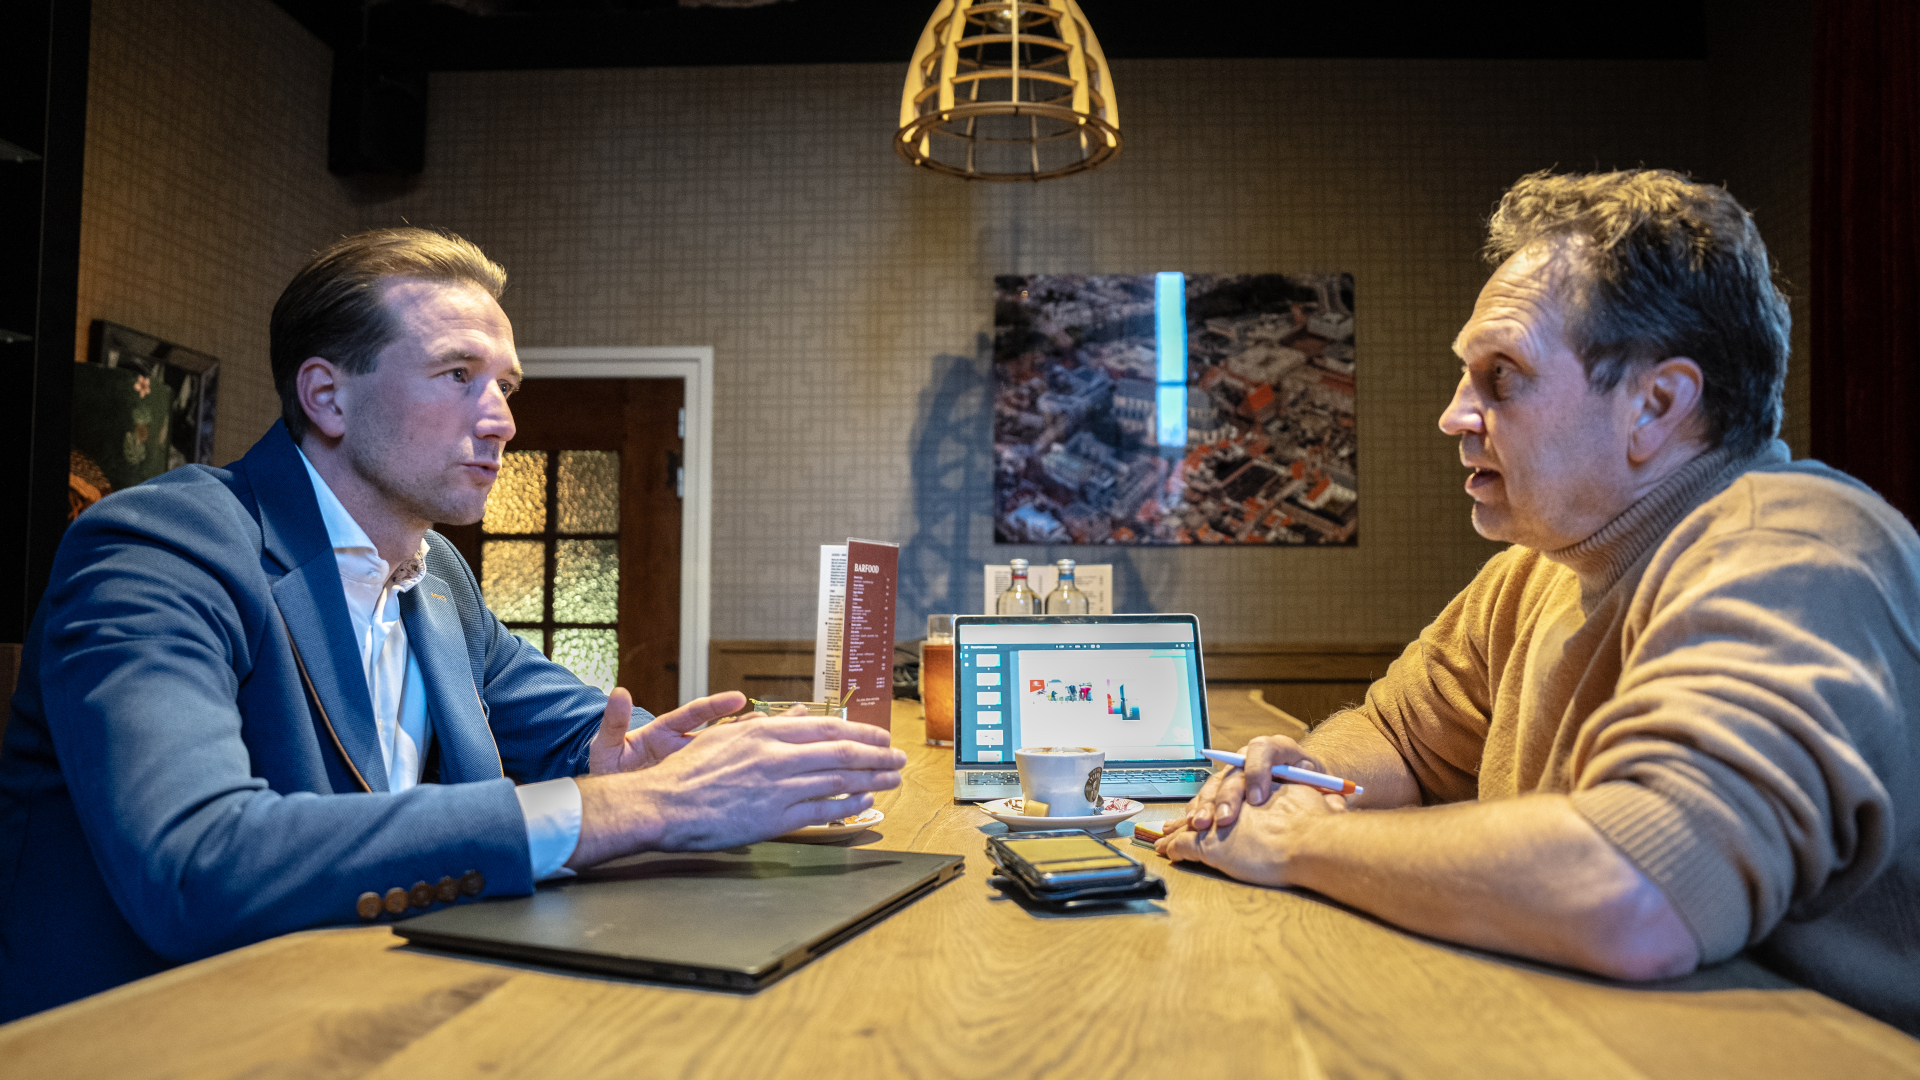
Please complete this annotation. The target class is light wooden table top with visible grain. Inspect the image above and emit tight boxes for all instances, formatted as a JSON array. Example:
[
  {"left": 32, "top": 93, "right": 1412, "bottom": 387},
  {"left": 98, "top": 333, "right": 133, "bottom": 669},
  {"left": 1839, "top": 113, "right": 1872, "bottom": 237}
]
[{"left": 0, "top": 696, "right": 1920, "bottom": 1080}]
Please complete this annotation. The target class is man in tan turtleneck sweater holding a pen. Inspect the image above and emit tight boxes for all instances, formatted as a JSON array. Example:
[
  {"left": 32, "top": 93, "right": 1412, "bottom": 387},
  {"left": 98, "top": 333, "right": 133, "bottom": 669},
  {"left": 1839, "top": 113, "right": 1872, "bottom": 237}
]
[{"left": 1160, "top": 171, "right": 1920, "bottom": 1034}]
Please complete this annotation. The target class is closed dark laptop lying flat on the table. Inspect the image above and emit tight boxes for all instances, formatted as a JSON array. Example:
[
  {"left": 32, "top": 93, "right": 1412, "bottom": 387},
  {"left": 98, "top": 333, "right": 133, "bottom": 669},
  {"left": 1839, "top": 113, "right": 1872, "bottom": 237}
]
[{"left": 394, "top": 844, "right": 966, "bottom": 992}]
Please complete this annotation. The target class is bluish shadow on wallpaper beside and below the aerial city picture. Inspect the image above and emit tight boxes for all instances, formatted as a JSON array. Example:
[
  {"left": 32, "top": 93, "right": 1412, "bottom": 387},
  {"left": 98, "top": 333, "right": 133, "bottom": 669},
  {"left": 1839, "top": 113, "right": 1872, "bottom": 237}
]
[{"left": 895, "top": 334, "right": 1154, "bottom": 626}]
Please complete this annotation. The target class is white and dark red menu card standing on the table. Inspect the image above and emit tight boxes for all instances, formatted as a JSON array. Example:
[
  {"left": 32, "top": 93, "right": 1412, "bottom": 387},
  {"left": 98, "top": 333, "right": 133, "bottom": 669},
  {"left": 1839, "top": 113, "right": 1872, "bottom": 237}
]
[{"left": 814, "top": 540, "right": 900, "bottom": 728}]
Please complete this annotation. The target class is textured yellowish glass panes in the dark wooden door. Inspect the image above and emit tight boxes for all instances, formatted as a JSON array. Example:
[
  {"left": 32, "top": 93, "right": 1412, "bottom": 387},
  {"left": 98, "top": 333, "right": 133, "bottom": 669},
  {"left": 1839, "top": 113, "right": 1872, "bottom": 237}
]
[{"left": 480, "top": 450, "right": 620, "bottom": 690}]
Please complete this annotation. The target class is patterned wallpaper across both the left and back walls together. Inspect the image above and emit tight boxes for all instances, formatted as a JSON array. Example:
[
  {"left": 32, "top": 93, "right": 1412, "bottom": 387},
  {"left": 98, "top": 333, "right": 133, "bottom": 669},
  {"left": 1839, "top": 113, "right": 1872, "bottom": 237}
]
[{"left": 71, "top": 0, "right": 1809, "bottom": 642}]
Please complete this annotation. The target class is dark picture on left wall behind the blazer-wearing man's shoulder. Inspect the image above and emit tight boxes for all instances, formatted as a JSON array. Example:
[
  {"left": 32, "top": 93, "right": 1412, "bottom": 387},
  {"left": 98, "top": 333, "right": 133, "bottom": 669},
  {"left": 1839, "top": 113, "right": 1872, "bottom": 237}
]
[{"left": 67, "top": 319, "right": 221, "bottom": 517}]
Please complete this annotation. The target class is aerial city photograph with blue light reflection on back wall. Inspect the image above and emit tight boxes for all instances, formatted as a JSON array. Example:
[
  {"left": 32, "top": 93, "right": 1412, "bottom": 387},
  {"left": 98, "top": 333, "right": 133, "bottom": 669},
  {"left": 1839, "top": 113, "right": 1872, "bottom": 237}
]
[{"left": 993, "top": 273, "right": 1359, "bottom": 546}]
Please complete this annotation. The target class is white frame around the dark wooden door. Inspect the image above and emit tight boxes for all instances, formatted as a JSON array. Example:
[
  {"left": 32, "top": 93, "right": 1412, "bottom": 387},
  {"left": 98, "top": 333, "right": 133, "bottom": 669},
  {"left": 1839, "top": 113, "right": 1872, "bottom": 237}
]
[{"left": 520, "top": 346, "right": 714, "bottom": 705}]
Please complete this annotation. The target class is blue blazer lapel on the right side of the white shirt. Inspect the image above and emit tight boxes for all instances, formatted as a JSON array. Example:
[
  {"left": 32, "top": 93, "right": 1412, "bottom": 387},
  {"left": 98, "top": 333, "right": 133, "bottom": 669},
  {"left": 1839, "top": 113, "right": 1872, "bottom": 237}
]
[{"left": 399, "top": 575, "right": 503, "bottom": 784}]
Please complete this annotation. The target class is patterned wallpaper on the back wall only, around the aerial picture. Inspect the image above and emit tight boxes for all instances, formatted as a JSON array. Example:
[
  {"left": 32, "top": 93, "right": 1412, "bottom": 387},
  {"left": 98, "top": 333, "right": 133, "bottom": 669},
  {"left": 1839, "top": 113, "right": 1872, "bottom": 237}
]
[{"left": 365, "top": 61, "right": 1805, "bottom": 642}]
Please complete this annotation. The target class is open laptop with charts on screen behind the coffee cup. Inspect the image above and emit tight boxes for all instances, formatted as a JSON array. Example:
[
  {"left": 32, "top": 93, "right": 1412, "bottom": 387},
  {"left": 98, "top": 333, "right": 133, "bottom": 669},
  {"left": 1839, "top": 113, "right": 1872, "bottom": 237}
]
[{"left": 954, "top": 615, "right": 1210, "bottom": 801}]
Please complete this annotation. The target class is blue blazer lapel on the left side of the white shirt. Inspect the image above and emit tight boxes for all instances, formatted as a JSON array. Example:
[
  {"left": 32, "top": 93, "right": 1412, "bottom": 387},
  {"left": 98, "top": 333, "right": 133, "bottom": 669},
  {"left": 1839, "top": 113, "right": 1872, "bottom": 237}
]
[{"left": 234, "top": 421, "right": 388, "bottom": 792}]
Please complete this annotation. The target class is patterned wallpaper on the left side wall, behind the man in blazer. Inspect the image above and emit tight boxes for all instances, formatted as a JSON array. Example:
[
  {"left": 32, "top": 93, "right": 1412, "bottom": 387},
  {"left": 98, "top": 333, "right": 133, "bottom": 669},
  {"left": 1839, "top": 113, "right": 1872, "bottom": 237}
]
[{"left": 79, "top": 0, "right": 355, "bottom": 461}]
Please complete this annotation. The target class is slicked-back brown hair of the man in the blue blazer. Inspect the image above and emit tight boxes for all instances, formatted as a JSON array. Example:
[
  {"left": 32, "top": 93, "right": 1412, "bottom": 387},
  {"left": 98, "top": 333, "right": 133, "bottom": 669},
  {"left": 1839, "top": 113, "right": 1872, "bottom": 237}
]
[{"left": 267, "top": 227, "right": 507, "bottom": 442}]
